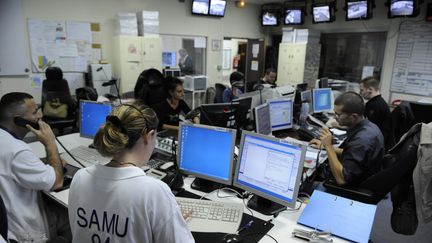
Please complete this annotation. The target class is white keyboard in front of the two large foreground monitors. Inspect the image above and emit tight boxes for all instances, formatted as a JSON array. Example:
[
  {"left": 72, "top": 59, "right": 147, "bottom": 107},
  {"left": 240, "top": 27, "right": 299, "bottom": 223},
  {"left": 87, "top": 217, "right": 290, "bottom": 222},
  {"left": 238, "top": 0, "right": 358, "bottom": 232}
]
[{"left": 176, "top": 197, "right": 244, "bottom": 233}]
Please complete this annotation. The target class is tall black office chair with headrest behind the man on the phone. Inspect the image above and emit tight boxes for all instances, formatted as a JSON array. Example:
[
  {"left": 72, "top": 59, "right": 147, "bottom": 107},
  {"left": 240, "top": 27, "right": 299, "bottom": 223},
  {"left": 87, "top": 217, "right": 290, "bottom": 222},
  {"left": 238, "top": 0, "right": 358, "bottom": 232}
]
[{"left": 42, "top": 67, "right": 77, "bottom": 135}]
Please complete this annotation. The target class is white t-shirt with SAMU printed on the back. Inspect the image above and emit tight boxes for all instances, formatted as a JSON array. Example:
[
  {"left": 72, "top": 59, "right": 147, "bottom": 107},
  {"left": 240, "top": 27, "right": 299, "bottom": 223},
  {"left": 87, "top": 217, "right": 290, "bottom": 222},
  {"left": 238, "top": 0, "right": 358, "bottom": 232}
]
[{"left": 68, "top": 165, "right": 194, "bottom": 243}]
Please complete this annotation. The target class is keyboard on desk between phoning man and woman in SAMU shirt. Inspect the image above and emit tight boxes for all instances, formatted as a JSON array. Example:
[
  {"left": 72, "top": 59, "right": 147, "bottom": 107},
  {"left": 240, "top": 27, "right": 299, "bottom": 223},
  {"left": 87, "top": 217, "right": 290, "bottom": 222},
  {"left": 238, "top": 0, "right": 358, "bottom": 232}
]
[{"left": 61, "top": 146, "right": 110, "bottom": 167}]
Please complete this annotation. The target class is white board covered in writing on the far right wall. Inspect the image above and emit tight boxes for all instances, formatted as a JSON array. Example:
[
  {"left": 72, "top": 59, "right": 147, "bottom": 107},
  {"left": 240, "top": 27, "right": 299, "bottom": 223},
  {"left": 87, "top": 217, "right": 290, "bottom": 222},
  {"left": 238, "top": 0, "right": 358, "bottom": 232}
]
[{"left": 391, "top": 21, "right": 432, "bottom": 96}]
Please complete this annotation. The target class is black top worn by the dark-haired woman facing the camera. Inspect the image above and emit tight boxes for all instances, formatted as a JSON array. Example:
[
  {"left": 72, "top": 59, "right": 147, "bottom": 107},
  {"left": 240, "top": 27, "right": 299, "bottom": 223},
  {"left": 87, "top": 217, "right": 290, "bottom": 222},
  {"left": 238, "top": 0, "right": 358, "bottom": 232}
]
[{"left": 152, "top": 99, "right": 191, "bottom": 130}]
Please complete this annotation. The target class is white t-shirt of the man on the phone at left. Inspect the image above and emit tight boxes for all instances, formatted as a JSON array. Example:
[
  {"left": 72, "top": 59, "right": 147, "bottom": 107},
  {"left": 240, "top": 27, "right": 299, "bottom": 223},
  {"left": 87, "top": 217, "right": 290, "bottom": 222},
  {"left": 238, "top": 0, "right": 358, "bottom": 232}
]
[{"left": 0, "top": 129, "right": 56, "bottom": 243}]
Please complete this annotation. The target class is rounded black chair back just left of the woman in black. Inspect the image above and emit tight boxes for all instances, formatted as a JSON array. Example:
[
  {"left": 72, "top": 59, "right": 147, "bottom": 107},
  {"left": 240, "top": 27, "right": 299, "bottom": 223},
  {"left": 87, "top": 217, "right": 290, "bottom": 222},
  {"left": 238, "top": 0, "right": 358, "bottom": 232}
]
[{"left": 134, "top": 68, "right": 167, "bottom": 107}]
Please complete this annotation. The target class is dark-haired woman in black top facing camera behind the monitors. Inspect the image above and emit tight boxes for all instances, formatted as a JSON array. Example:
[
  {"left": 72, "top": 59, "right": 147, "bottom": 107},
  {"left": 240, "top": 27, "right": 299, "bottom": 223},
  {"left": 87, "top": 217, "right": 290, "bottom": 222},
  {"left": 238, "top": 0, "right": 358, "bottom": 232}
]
[{"left": 153, "top": 77, "right": 199, "bottom": 130}]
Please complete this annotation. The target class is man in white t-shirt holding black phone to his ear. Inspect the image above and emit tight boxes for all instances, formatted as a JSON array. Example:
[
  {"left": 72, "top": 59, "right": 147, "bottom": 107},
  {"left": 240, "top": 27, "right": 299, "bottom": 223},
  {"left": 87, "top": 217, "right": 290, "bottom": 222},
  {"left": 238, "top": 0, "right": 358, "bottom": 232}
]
[{"left": 0, "top": 92, "right": 67, "bottom": 242}]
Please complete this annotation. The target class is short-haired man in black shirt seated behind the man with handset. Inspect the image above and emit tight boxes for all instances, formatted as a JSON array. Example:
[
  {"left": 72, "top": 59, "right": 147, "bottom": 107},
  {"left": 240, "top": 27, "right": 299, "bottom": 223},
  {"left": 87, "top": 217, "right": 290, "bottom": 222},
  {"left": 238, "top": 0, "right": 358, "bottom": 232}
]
[{"left": 360, "top": 77, "right": 390, "bottom": 139}]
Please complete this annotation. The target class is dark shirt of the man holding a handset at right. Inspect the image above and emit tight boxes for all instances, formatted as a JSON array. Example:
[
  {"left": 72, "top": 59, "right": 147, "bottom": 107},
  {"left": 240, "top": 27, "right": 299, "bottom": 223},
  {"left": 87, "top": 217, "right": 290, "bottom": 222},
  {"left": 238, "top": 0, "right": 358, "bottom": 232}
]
[{"left": 341, "top": 119, "right": 385, "bottom": 185}]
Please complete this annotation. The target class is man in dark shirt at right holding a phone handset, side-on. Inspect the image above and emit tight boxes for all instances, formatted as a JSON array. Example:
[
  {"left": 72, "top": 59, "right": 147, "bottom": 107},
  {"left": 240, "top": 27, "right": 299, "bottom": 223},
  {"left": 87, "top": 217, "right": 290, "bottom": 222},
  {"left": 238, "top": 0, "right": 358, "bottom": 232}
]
[{"left": 311, "top": 92, "right": 384, "bottom": 185}]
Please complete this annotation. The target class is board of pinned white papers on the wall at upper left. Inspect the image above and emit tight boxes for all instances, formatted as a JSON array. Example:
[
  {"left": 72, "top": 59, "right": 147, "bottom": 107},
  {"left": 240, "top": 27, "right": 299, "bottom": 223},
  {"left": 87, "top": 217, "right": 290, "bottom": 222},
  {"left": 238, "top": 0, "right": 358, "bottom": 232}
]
[{"left": 27, "top": 19, "right": 101, "bottom": 73}]
